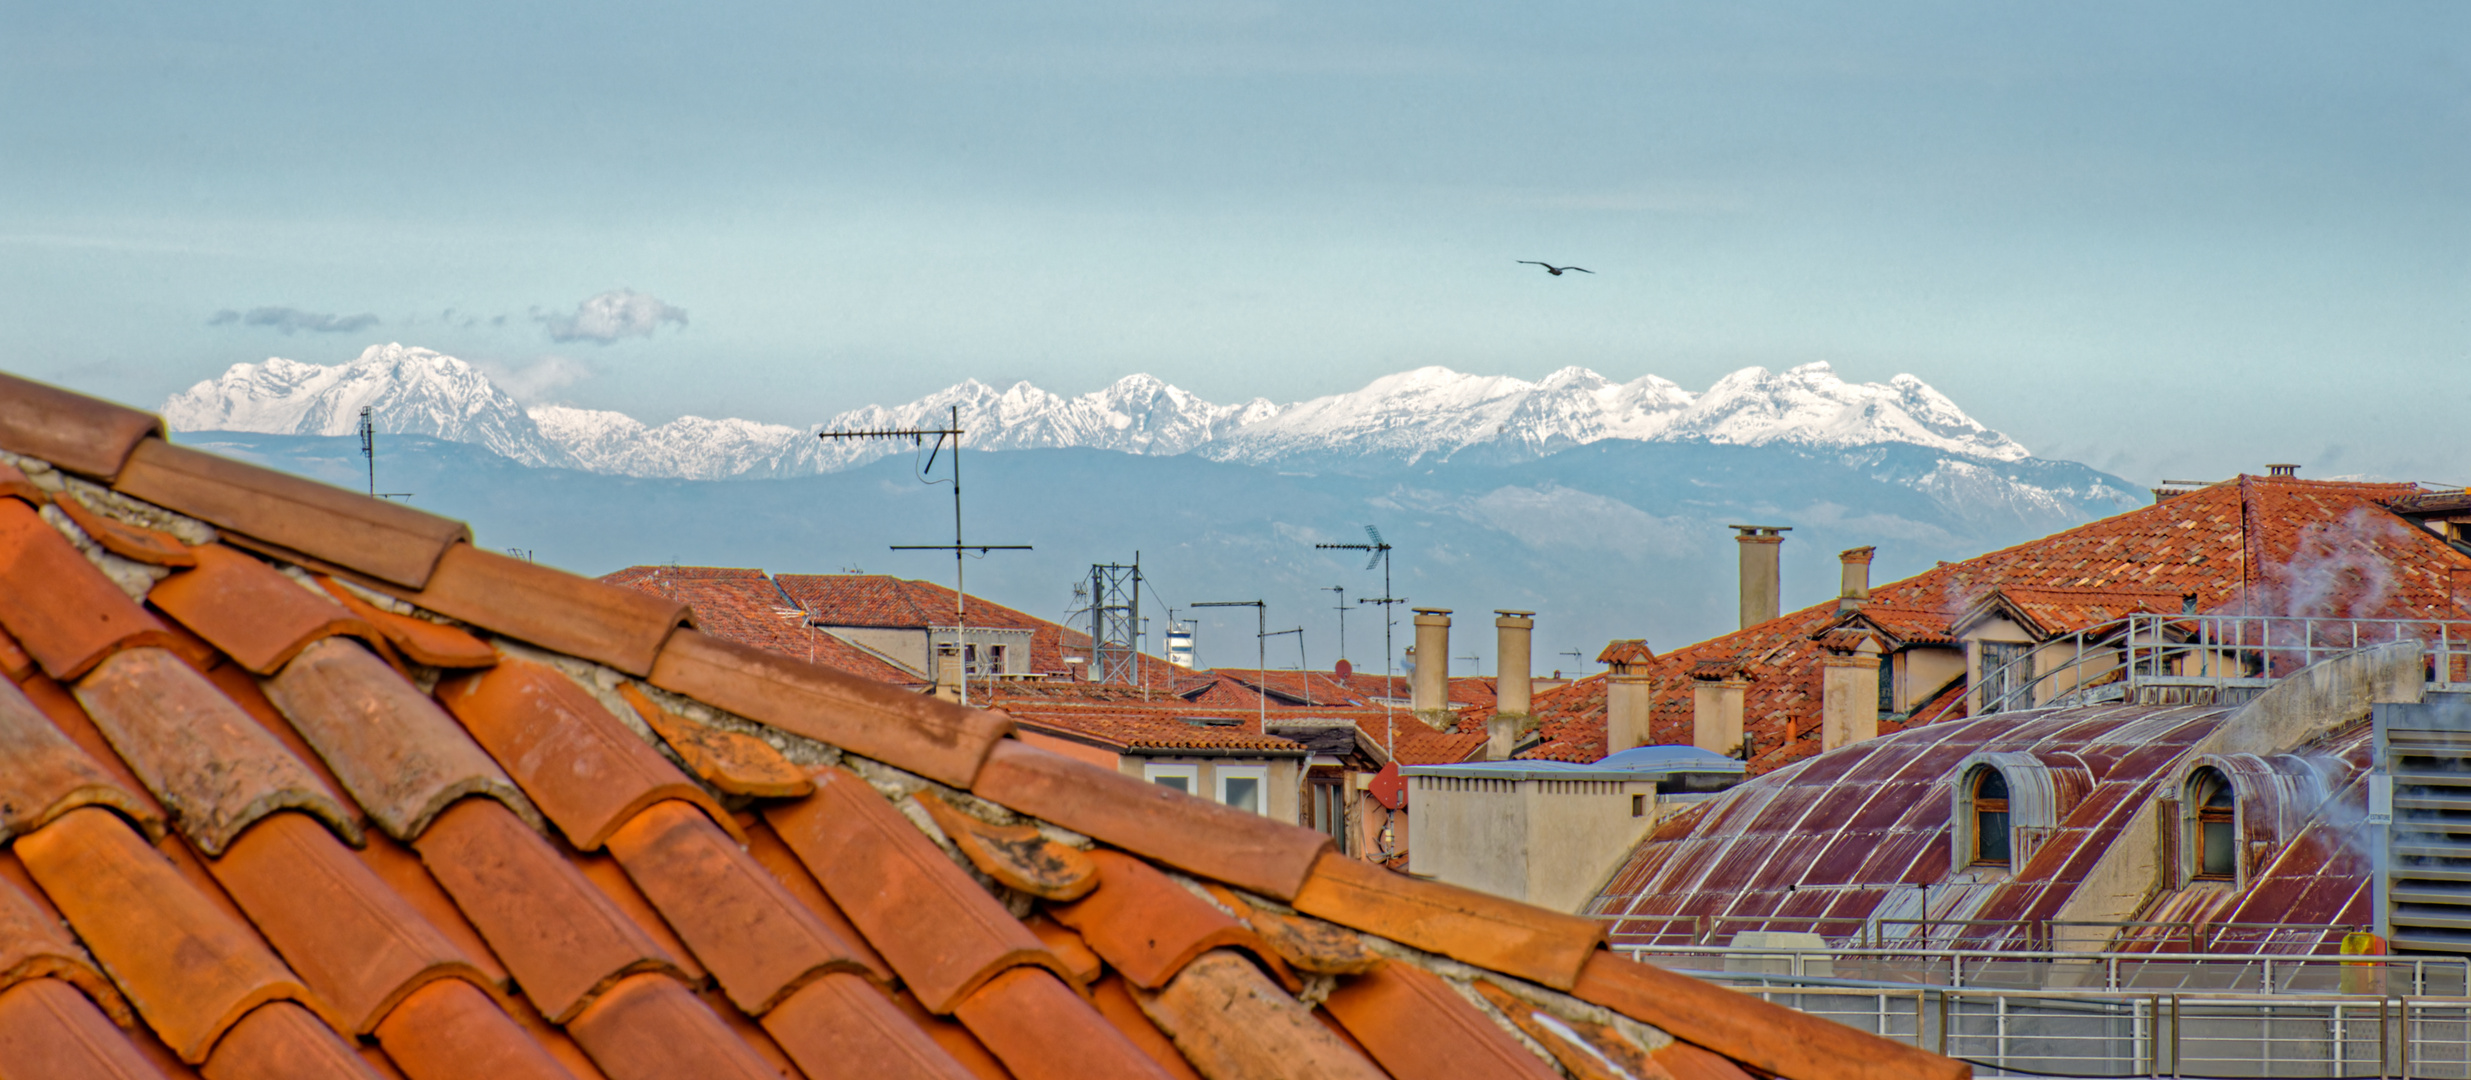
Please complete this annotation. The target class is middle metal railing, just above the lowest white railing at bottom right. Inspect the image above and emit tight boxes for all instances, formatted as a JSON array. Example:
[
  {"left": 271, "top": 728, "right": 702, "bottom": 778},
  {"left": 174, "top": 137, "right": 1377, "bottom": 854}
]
[{"left": 1614, "top": 944, "right": 2471, "bottom": 996}]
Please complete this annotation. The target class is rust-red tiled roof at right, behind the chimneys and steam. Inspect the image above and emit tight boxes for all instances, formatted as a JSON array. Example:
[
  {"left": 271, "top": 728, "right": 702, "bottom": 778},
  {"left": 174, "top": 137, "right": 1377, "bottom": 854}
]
[{"left": 1522, "top": 477, "right": 2471, "bottom": 774}]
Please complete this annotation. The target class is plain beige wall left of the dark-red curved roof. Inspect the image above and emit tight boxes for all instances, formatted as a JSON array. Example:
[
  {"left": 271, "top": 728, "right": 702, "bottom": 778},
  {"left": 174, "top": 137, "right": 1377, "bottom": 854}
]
[{"left": 1408, "top": 776, "right": 1656, "bottom": 912}]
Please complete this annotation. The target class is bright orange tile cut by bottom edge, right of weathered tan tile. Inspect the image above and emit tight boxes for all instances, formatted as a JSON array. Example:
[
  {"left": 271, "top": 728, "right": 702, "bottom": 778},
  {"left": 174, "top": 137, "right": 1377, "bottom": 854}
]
[{"left": 1322, "top": 959, "right": 1559, "bottom": 1080}]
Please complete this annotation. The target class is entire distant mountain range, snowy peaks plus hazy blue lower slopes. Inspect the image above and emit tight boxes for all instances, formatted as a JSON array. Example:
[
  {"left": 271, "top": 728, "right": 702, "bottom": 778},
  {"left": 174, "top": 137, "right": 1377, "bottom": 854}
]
[{"left": 163, "top": 346, "right": 2142, "bottom": 657}]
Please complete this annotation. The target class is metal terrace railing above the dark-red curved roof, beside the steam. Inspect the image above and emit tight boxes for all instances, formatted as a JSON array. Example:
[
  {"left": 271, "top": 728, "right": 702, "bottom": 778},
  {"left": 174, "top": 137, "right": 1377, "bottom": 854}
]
[{"left": 1979, "top": 613, "right": 2471, "bottom": 712}]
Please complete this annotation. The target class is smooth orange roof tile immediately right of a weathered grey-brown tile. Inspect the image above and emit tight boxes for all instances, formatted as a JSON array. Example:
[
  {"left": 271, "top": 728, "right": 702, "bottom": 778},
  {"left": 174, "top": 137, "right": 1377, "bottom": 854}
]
[{"left": 437, "top": 657, "right": 729, "bottom": 850}]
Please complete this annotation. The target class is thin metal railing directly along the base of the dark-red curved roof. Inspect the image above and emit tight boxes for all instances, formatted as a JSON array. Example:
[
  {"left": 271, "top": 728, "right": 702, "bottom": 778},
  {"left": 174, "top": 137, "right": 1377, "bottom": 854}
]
[{"left": 1596, "top": 912, "right": 2372, "bottom": 954}]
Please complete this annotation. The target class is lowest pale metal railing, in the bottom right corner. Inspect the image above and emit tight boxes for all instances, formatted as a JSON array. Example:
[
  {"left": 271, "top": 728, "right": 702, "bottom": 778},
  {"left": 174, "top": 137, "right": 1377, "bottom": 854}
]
[{"left": 1732, "top": 981, "right": 2471, "bottom": 1080}]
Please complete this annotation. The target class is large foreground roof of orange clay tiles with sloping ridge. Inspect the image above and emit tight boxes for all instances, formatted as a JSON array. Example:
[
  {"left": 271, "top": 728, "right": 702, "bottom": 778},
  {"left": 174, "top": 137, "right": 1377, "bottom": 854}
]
[{"left": 0, "top": 376, "right": 1967, "bottom": 1080}]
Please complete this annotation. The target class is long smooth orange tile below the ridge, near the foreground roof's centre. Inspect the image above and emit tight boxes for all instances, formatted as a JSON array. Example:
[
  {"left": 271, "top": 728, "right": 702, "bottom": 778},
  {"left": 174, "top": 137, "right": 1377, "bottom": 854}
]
[{"left": 766, "top": 769, "right": 1063, "bottom": 1013}]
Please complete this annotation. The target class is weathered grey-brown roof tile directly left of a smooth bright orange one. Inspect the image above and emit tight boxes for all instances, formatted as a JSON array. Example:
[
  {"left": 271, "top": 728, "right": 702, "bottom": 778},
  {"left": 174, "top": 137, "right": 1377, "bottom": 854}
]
[{"left": 264, "top": 640, "right": 539, "bottom": 840}]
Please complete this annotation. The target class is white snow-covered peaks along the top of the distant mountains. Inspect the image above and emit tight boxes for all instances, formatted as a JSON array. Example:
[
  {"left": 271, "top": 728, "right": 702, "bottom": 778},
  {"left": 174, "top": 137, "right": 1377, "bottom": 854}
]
[{"left": 163, "top": 344, "right": 2029, "bottom": 479}]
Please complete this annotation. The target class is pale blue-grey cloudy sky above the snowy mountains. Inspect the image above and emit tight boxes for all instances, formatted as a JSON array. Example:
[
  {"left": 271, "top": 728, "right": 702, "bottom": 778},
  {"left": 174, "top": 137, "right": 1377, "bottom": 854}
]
[{"left": 0, "top": 0, "right": 2471, "bottom": 484}]
